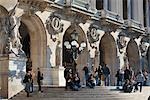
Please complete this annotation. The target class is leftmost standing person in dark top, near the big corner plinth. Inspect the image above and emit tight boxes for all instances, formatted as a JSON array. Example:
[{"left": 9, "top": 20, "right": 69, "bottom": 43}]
[{"left": 23, "top": 71, "right": 31, "bottom": 97}]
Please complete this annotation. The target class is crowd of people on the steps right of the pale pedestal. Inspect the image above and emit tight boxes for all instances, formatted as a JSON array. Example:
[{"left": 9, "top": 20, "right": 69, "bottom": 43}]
[{"left": 64, "top": 64, "right": 149, "bottom": 93}]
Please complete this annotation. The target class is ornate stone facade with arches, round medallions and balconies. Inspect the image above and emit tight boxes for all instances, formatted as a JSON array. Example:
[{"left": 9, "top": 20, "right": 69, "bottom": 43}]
[{"left": 0, "top": 0, "right": 150, "bottom": 98}]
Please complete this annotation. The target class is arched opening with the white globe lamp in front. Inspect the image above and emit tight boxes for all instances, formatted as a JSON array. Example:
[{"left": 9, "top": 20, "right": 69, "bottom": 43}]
[{"left": 62, "top": 25, "right": 89, "bottom": 80}]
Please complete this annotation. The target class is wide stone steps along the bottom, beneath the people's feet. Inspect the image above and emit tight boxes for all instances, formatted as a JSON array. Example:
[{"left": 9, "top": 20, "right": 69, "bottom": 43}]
[{"left": 10, "top": 86, "right": 150, "bottom": 100}]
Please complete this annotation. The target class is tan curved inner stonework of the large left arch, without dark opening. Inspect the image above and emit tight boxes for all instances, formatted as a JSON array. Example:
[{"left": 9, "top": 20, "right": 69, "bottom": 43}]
[{"left": 20, "top": 14, "right": 47, "bottom": 70}]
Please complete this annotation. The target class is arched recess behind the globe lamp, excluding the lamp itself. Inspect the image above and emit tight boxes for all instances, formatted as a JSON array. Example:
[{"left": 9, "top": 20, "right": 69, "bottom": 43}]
[{"left": 62, "top": 25, "right": 89, "bottom": 76}]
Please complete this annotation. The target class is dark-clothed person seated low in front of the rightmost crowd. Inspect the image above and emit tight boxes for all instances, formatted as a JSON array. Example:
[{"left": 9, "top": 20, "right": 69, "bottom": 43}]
[{"left": 123, "top": 79, "right": 133, "bottom": 93}]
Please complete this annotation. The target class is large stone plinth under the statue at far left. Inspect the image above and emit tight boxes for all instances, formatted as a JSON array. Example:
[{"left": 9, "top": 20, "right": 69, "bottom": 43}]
[{"left": 0, "top": 57, "right": 26, "bottom": 98}]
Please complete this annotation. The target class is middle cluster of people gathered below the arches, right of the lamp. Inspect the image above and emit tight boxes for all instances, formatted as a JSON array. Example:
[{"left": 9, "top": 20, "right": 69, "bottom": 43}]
[{"left": 83, "top": 64, "right": 110, "bottom": 87}]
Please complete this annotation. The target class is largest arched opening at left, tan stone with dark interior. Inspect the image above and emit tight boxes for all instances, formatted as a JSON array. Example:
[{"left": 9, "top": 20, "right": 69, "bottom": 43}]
[{"left": 19, "top": 14, "right": 46, "bottom": 73}]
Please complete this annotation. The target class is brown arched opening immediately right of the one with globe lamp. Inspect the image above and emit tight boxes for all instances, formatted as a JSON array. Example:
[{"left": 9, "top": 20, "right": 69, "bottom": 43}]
[{"left": 99, "top": 33, "right": 119, "bottom": 85}]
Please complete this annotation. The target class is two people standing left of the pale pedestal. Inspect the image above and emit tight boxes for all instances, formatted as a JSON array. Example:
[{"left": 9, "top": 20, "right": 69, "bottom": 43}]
[{"left": 23, "top": 68, "right": 43, "bottom": 97}]
